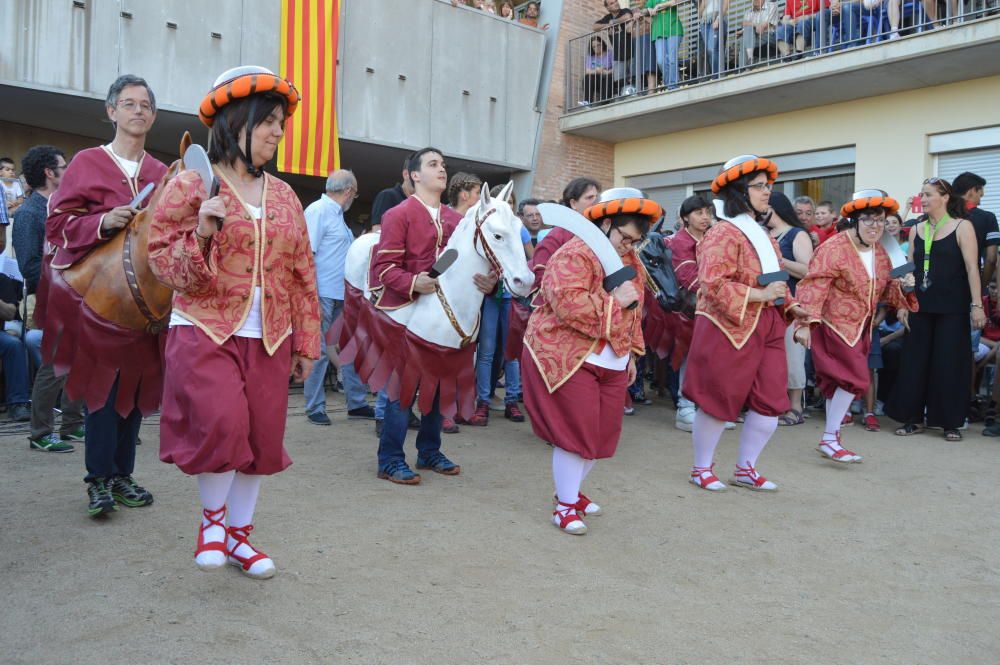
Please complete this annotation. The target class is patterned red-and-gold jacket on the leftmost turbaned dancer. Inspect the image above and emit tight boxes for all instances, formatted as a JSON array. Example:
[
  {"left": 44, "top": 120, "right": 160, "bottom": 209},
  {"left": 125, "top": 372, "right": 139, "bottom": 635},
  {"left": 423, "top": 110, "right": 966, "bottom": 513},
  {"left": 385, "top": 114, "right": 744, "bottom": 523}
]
[{"left": 149, "top": 171, "right": 320, "bottom": 358}]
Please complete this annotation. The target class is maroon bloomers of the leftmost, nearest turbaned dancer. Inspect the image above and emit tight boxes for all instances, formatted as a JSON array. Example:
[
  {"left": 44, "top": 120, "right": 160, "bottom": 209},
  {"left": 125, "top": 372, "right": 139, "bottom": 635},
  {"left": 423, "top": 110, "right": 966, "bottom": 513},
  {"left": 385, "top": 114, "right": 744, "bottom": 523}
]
[{"left": 160, "top": 326, "right": 292, "bottom": 475}]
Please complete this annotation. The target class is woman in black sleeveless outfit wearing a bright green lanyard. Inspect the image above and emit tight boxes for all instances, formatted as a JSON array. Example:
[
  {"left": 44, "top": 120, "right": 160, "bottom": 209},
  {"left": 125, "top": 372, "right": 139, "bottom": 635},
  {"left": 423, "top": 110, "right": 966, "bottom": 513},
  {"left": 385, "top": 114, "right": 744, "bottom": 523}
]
[{"left": 885, "top": 178, "right": 986, "bottom": 441}]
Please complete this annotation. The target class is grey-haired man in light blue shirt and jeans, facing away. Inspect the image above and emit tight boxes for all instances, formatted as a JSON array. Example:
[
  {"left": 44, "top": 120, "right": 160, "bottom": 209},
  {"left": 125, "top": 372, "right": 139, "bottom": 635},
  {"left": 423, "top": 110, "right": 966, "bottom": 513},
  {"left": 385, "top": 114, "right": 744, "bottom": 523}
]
[{"left": 304, "top": 170, "right": 375, "bottom": 425}]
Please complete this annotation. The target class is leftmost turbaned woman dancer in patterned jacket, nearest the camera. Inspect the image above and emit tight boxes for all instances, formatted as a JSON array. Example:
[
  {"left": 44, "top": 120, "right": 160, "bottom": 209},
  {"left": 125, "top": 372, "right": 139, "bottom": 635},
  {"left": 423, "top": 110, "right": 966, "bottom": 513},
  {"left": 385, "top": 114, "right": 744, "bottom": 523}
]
[{"left": 149, "top": 67, "right": 320, "bottom": 579}]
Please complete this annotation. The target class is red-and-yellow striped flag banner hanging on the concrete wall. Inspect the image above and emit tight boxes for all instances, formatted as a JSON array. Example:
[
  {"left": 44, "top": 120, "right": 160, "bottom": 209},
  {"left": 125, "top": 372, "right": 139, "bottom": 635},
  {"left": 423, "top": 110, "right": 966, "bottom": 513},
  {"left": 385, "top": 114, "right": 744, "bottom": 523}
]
[{"left": 278, "top": 0, "right": 340, "bottom": 178}]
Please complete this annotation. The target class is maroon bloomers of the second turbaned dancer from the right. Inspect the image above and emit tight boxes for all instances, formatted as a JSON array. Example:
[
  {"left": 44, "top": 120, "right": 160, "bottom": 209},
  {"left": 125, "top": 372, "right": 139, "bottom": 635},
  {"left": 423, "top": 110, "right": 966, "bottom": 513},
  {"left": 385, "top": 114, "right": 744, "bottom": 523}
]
[{"left": 681, "top": 307, "right": 789, "bottom": 422}]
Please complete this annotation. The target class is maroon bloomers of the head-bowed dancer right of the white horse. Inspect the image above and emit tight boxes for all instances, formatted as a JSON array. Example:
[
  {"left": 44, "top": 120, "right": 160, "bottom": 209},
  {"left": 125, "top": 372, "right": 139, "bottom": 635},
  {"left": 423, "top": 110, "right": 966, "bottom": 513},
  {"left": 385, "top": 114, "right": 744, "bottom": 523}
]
[{"left": 521, "top": 347, "right": 628, "bottom": 459}]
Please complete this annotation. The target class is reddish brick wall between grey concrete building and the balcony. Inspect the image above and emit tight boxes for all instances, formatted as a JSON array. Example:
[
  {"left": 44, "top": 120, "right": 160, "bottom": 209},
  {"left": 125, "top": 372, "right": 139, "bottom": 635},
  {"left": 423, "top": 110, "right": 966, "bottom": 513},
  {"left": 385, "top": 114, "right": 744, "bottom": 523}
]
[{"left": 533, "top": 0, "right": 614, "bottom": 200}]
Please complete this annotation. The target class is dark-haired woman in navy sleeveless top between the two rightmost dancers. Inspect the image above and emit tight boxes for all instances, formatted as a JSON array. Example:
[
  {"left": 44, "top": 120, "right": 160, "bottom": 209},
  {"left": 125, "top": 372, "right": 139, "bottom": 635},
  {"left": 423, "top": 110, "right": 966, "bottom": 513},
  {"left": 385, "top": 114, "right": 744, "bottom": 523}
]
[{"left": 767, "top": 192, "right": 813, "bottom": 426}]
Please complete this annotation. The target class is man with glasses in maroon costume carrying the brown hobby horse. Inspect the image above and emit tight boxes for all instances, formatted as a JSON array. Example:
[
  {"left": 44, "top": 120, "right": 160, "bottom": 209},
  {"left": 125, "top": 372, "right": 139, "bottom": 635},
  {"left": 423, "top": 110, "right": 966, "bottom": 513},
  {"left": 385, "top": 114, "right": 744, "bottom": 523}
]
[{"left": 43, "top": 75, "right": 167, "bottom": 517}]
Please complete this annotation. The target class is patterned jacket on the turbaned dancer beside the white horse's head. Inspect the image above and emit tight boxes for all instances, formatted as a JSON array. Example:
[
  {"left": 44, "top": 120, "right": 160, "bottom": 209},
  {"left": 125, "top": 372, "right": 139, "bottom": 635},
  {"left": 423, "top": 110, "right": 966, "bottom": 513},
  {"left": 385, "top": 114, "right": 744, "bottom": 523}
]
[{"left": 524, "top": 238, "right": 646, "bottom": 393}]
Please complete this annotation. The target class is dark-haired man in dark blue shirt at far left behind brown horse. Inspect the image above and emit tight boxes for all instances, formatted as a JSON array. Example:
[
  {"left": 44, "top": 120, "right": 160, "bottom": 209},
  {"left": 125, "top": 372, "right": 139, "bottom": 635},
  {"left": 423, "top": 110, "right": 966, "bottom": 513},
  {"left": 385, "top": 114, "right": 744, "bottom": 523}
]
[{"left": 12, "top": 145, "right": 83, "bottom": 453}]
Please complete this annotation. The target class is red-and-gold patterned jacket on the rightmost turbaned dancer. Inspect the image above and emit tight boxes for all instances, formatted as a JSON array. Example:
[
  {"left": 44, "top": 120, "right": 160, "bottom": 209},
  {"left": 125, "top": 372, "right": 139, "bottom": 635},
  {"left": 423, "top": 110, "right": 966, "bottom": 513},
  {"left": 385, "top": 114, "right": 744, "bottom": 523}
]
[{"left": 795, "top": 231, "right": 919, "bottom": 346}]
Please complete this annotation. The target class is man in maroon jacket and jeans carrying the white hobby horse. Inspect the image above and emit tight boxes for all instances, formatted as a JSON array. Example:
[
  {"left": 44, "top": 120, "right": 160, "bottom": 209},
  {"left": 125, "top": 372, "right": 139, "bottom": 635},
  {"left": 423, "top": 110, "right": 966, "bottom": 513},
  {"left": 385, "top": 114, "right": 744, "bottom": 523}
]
[{"left": 362, "top": 148, "right": 497, "bottom": 485}]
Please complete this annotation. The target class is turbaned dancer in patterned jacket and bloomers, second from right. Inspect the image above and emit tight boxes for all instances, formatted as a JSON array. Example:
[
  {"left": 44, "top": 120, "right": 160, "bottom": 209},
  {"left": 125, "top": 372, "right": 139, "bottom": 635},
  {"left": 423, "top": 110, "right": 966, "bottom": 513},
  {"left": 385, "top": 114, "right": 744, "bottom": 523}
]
[{"left": 684, "top": 155, "right": 807, "bottom": 492}]
